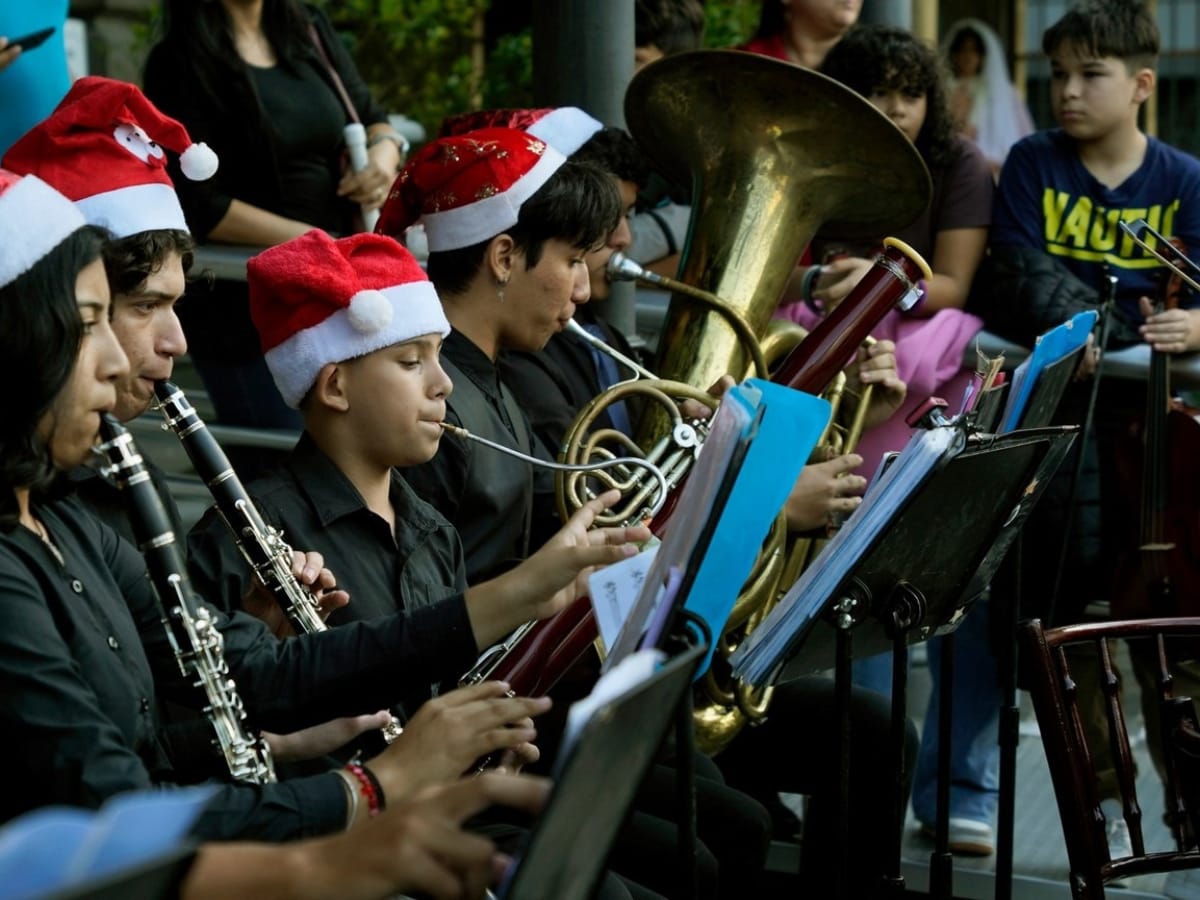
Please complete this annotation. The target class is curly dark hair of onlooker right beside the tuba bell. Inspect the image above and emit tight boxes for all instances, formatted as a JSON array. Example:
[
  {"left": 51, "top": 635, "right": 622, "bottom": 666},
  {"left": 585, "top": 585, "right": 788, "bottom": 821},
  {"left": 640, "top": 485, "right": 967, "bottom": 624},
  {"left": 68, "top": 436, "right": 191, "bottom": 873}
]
[{"left": 821, "top": 24, "right": 960, "bottom": 172}]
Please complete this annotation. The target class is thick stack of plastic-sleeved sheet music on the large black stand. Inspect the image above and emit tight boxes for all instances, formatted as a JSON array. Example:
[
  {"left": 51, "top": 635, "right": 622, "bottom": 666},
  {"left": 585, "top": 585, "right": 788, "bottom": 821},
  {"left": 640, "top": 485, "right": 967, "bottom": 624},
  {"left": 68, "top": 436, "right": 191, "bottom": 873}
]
[{"left": 730, "top": 426, "right": 966, "bottom": 686}]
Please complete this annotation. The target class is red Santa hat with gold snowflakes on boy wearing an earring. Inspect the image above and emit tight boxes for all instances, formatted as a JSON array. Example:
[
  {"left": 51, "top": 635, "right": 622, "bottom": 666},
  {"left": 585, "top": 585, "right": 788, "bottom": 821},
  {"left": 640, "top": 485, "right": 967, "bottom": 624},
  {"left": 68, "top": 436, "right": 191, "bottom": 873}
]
[{"left": 376, "top": 128, "right": 566, "bottom": 253}]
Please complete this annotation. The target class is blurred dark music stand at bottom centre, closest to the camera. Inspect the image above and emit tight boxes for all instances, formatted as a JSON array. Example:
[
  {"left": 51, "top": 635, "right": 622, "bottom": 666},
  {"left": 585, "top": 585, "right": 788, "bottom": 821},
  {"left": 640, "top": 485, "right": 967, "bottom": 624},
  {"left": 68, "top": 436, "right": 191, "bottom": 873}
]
[{"left": 498, "top": 646, "right": 706, "bottom": 900}]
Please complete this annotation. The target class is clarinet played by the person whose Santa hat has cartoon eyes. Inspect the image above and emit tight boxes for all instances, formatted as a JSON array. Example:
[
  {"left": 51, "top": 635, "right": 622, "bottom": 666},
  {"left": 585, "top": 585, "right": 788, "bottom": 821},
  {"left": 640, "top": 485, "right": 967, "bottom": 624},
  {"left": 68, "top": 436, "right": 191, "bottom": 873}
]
[{"left": 155, "top": 380, "right": 403, "bottom": 744}]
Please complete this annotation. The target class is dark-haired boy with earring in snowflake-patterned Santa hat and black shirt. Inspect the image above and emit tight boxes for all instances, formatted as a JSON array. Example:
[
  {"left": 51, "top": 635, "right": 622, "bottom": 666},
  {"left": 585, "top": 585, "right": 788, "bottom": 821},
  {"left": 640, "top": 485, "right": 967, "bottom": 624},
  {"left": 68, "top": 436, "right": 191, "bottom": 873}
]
[{"left": 376, "top": 128, "right": 622, "bottom": 580}]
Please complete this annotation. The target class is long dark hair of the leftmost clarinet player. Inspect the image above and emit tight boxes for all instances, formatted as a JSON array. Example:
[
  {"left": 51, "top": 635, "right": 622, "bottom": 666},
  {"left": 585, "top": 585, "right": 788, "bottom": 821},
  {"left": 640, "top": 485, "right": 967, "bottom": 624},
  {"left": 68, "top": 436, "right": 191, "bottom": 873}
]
[{"left": 0, "top": 226, "right": 104, "bottom": 530}]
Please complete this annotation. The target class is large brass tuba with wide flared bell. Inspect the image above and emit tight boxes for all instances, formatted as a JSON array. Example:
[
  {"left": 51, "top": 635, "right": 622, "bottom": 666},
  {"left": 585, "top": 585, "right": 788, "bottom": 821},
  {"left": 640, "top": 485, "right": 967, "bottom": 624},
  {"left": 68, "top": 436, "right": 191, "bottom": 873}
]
[{"left": 564, "top": 50, "right": 930, "bottom": 752}]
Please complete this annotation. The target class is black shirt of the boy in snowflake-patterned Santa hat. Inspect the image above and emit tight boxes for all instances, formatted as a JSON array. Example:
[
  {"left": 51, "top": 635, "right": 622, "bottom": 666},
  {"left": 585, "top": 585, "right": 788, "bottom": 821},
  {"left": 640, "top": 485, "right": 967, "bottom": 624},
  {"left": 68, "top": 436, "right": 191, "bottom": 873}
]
[{"left": 402, "top": 330, "right": 558, "bottom": 582}]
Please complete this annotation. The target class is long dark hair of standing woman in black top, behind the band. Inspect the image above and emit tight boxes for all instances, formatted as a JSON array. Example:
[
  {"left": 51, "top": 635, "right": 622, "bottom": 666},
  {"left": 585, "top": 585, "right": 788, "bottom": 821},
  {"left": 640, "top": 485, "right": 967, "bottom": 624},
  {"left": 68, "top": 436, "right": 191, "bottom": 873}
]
[{"left": 163, "top": 0, "right": 314, "bottom": 124}]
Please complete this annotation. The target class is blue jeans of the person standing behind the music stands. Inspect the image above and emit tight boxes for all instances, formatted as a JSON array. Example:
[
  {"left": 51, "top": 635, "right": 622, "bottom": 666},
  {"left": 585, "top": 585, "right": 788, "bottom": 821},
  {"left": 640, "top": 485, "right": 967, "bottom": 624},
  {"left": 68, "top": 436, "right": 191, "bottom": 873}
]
[{"left": 854, "top": 596, "right": 1001, "bottom": 824}]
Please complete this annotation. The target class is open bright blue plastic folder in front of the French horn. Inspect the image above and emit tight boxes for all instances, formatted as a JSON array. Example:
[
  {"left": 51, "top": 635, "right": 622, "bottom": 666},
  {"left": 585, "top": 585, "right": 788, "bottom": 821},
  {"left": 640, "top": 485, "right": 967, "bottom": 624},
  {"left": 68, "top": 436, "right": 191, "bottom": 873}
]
[{"left": 605, "top": 378, "right": 830, "bottom": 674}]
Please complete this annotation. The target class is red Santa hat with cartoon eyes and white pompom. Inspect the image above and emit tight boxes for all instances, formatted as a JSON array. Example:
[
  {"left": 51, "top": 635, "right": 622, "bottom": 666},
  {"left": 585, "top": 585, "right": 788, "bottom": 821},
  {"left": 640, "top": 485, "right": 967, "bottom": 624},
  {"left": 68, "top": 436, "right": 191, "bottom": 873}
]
[{"left": 4, "top": 76, "right": 217, "bottom": 238}]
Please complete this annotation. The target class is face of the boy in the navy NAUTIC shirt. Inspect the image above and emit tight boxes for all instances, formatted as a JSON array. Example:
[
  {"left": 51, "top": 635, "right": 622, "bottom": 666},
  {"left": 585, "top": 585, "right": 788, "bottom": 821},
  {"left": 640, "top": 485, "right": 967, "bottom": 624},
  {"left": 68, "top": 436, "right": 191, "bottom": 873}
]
[{"left": 1050, "top": 43, "right": 1154, "bottom": 140}]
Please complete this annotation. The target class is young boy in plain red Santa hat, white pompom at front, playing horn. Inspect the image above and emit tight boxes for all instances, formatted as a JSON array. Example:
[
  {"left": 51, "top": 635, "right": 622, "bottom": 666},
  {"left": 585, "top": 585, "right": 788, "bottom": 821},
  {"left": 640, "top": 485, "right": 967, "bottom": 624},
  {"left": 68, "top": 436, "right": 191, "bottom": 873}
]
[{"left": 188, "top": 230, "right": 649, "bottom": 801}]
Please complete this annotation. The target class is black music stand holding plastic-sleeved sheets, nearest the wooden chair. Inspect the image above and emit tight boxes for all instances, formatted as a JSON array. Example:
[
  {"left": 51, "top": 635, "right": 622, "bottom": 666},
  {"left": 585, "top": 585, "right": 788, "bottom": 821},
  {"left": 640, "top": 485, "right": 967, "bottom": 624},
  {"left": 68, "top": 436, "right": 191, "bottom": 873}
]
[{"left": 758, "top": 426, "right": 1074, "bottom": 896}]
